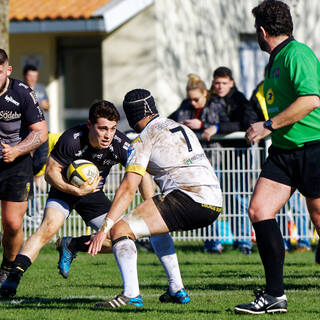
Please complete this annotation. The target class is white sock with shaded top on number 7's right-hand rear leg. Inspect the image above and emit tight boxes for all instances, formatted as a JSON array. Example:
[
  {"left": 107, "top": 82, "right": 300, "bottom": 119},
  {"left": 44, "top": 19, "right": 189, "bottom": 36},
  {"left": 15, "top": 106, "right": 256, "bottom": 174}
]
[{"left": 150, "top": 233, "right": 183, "bottom": 295}]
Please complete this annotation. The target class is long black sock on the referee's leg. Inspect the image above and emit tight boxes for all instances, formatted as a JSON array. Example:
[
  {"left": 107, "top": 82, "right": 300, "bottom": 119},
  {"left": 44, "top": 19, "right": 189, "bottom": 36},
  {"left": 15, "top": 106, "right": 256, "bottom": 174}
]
[{"left": 253, "top": 219, "right": 284, "bottom": 297}]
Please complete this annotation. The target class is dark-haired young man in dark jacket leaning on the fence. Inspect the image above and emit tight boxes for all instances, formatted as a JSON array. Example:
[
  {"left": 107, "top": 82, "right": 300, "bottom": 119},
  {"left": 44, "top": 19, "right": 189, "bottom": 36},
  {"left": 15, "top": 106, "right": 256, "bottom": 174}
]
[{"left": 208, "top": 67, "right": 252, "bottom": 254}]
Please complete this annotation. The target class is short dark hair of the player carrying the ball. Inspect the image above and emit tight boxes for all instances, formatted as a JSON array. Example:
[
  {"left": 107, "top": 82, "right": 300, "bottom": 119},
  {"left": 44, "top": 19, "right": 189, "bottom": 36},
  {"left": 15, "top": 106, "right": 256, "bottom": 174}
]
[{"left": 89, "top": 100, "right": 120, "bottom": 124}]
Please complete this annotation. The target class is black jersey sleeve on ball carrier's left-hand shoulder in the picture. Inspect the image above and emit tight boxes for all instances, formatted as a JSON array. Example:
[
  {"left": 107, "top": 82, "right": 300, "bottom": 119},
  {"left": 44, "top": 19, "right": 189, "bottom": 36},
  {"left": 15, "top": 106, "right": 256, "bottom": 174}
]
[{"left": 50, "top": 129, "right": 81, "bottom": 167}]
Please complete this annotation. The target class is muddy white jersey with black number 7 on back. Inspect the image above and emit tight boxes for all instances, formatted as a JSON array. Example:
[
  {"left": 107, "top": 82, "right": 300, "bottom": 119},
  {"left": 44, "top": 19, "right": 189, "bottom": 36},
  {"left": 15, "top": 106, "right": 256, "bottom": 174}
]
[{"left": 126, "top": 117, "right": 222, "bottom": 207}]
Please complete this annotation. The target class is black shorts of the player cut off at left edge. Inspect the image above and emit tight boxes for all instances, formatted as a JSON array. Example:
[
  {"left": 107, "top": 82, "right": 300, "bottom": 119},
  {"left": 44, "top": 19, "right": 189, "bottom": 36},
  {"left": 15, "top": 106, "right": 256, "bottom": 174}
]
[{"left": 0, "top": 154, "right": 33, "bottom": 202}]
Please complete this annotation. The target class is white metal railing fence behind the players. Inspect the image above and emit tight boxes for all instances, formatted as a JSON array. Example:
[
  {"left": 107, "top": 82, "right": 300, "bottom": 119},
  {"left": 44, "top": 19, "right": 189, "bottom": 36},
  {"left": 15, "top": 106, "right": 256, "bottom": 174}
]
[{"left": 23, "top": 135, "right": 316, "bottom": 244}]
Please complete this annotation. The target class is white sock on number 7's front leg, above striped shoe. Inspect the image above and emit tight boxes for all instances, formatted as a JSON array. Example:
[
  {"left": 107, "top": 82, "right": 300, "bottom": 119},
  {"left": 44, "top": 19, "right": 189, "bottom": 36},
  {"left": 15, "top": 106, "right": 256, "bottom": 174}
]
[{"left": 113, "top": 239, "right": 139, "bottom": 298}]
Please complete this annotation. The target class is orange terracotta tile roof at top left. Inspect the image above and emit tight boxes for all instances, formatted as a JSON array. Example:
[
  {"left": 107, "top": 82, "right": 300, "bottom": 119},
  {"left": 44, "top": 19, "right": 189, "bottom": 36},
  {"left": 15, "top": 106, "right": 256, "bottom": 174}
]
[{"left": 9, "top": 0, "right": 112, "bottom": 21}]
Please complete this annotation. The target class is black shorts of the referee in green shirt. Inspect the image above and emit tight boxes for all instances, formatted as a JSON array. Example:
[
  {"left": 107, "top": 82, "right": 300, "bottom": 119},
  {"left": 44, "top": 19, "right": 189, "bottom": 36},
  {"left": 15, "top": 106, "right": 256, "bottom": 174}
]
[{"left": 260, "top": 141, "right": 320, "bottom": 198}]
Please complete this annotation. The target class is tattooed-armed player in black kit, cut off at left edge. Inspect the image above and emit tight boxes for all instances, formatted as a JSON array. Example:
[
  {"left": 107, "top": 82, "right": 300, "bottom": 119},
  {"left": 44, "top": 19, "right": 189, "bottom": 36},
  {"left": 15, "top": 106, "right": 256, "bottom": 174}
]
[{"left": 0, "top": 49, "right": 48, "bottom": 284}]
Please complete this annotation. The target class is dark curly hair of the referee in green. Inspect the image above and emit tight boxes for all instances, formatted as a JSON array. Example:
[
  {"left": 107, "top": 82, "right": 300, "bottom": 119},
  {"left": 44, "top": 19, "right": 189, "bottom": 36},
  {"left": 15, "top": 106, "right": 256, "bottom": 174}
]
[{"left": 252, "top": 0, "right": 293, "bottom": 37}]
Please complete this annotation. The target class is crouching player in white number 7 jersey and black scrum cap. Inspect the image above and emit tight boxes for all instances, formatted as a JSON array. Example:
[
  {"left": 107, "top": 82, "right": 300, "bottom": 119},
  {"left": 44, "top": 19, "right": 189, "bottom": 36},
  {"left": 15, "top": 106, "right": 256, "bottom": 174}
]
[{"left": 88, "top": 89, "right": 222, "bottom": 308}]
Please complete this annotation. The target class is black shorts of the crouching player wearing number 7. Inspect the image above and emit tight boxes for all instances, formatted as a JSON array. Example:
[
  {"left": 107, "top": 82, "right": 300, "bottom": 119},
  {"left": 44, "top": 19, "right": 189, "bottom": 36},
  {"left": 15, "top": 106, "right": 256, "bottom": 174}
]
[{"left": 152, "top": 190, "right": 221, "bottom": 231}]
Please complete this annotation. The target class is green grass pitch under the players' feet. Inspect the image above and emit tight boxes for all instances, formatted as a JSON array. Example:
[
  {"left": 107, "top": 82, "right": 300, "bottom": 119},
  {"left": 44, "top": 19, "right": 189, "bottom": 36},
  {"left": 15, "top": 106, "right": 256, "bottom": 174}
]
[{"left": 0, "top": 242, "right": 320, "bottom": 320}]
